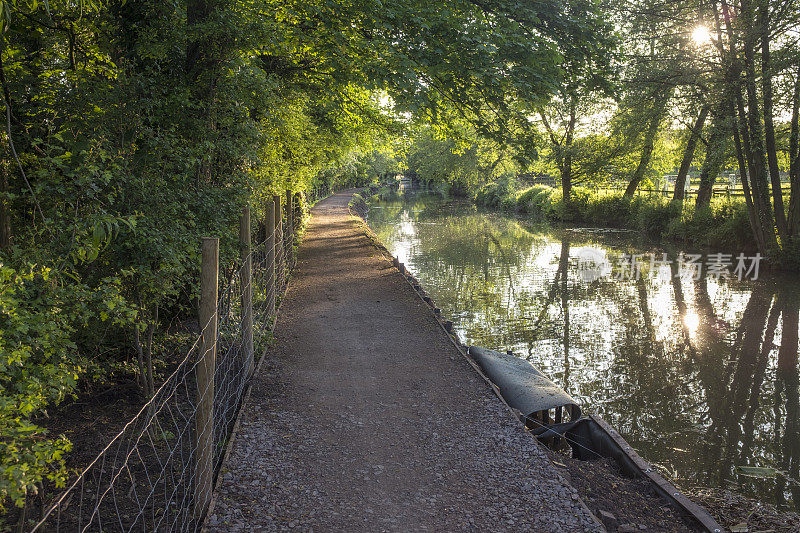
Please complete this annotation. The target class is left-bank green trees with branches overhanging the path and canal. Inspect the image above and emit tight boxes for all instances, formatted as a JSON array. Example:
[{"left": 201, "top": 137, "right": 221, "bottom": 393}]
[{"left": 0, "top": 0, "right": 609, "bottom": 505}]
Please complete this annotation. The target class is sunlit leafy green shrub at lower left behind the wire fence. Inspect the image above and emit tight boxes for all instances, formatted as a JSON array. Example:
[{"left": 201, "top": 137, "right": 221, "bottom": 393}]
[{"left": 0, "top": 265, "right": 133, "bottom": 505}]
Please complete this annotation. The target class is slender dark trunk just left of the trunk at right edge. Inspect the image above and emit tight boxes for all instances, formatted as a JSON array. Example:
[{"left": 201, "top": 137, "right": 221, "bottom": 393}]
[{"left": 764, "top": 1, "right": 789, "bottom": 239}]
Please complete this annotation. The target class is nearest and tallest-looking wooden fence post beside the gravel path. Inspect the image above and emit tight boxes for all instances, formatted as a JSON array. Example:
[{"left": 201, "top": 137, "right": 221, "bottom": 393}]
[{"left": 193, "top": 237, "right": 219, "bottom": 521}]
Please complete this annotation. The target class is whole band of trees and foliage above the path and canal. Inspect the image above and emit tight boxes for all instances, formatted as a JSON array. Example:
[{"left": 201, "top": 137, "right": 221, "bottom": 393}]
[{"left": 0, "top": 0, "right": 800, "bottom": 506}]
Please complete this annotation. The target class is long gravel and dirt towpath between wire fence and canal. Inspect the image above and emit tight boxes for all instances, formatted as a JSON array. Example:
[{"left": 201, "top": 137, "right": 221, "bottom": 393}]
[{"left": 207, "top": 189, "right": 599, "bottom": 532}]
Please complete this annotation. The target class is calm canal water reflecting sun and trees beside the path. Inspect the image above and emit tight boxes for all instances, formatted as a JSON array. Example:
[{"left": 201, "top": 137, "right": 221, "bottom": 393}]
[{"left": 368, "top": 192, "right": 800, "bottom": 510}]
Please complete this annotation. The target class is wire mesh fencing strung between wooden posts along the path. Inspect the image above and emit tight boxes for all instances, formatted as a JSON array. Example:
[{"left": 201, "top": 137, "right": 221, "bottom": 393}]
[{"left": 29, "top": 216, "right": 294, "bottom": 533}]
